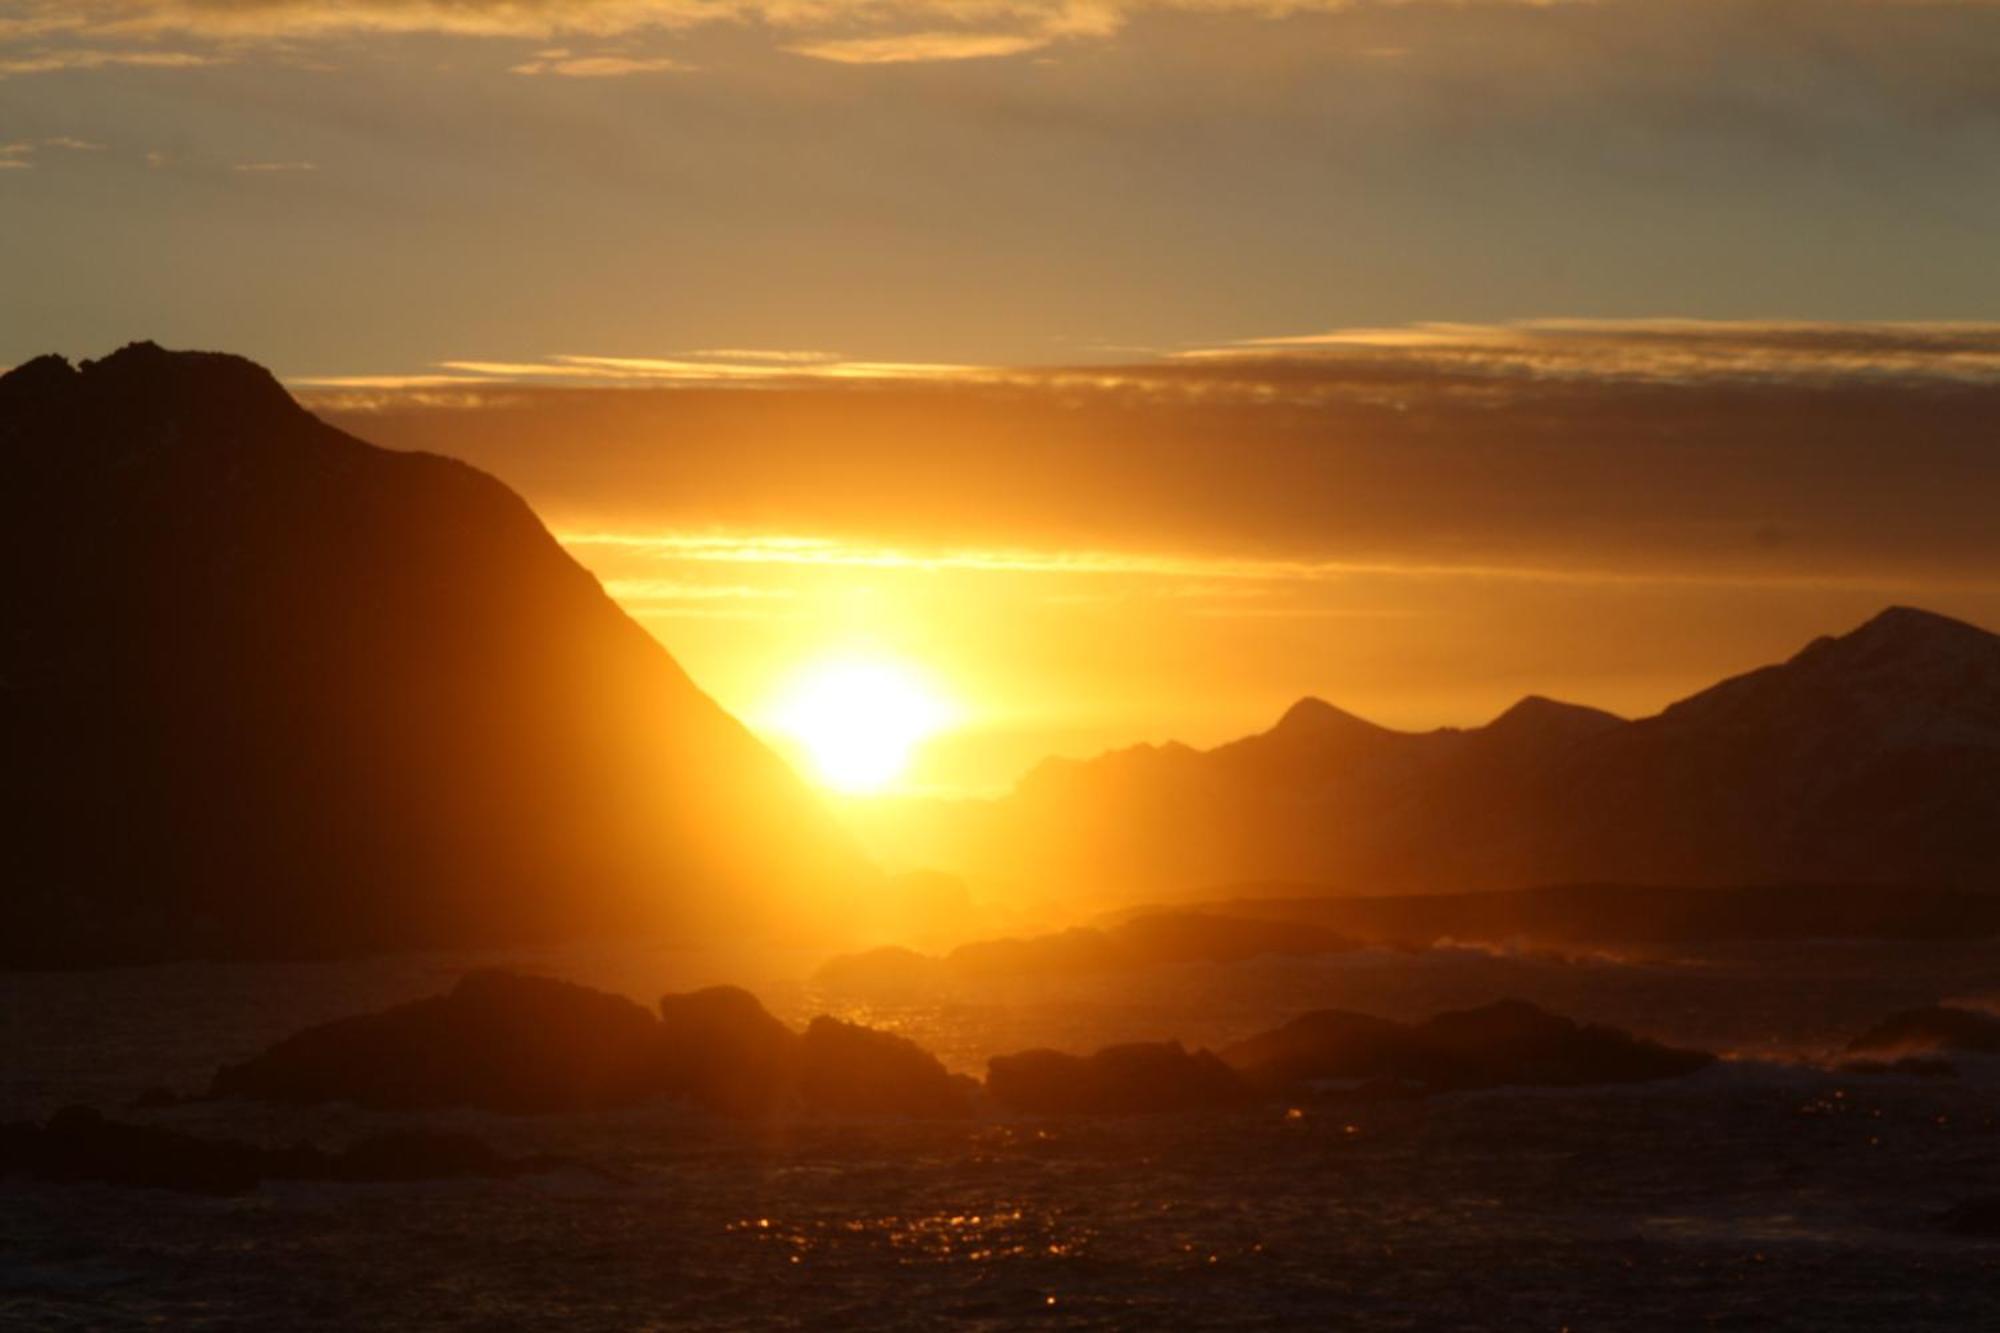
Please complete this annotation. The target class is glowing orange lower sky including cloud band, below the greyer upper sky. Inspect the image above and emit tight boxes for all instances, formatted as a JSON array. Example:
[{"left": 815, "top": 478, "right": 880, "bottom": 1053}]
[{"left": 308, "top": 324, "right": 2000, "bottom": 793}]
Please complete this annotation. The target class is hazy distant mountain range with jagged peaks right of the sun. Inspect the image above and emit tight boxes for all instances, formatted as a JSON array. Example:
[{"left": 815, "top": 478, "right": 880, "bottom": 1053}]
[{"left": 918, "top": 606, "right": 2000, "bottom": 901}]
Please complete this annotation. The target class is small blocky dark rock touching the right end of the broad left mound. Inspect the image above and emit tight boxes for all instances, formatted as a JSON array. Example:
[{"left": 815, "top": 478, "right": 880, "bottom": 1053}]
[{"left": 660, "top": 987, "right": 800, "bottom": 1115}]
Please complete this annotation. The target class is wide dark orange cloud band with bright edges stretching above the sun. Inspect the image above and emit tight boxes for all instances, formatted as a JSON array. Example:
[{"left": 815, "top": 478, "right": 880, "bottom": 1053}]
[{"left": 316, "top": 320, "right": 2000, "bottom": 592}]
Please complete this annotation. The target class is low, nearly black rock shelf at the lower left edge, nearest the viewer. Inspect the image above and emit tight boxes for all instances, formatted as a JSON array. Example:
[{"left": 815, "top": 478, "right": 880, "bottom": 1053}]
[{"left": 0, "top": 1107, "right": 564, "bottom": 1195}]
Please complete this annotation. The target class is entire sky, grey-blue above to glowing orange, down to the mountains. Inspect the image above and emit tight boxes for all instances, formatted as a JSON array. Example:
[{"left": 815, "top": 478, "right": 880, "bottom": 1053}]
[{"left": 0, "top": 0, "right": 2000, "bottom": 791}]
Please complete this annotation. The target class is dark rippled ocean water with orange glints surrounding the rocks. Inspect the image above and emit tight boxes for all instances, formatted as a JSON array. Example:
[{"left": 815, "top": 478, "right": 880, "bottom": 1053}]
[{"left": 0, "top": 943, "right": 2000, "bottom": 1329}]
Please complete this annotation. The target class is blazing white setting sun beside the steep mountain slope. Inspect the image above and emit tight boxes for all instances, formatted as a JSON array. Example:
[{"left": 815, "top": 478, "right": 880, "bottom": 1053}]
[{"left": 766, "top": 658, "right": 956, "bottom": 793}]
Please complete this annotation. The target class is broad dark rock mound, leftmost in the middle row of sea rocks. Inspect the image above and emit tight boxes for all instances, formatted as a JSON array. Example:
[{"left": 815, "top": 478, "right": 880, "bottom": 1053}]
[{"left": 210, "top": 971, "right": 666, "bottom": 1111}]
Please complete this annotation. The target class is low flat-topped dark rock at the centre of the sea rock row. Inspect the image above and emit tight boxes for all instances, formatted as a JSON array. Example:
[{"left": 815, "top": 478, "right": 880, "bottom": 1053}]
[{"left": 986, "top": 1041, "right": 1256, "bottom": 1115}]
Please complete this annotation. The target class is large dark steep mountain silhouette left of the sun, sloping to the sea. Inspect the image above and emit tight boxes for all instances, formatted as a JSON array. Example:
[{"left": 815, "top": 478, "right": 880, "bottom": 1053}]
[{"left": 0, "top": 342, "right": 870, "bottom": 965}]
